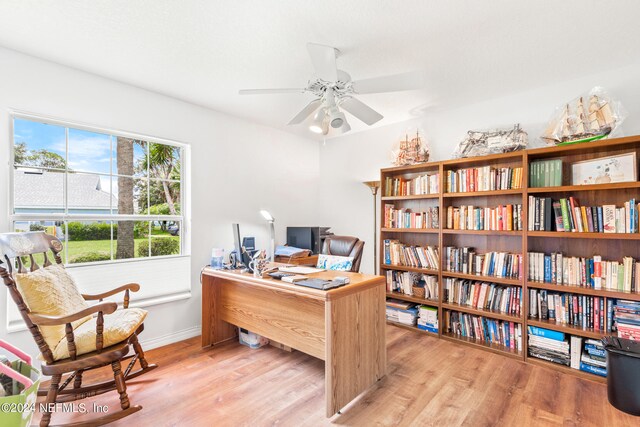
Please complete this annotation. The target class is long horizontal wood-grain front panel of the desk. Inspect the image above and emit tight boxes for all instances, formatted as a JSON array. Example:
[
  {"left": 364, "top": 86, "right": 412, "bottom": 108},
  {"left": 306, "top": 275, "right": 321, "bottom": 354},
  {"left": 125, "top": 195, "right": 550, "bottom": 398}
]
[{"left": 219, "top": 281, "right": 325, "bottom": 360}]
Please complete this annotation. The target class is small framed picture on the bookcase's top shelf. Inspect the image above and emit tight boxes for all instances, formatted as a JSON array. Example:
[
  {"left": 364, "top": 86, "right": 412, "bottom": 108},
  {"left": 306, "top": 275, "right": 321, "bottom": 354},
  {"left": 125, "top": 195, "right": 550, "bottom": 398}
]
[{"left": 571, "top": 151, "right": 638, "bottom": 185}]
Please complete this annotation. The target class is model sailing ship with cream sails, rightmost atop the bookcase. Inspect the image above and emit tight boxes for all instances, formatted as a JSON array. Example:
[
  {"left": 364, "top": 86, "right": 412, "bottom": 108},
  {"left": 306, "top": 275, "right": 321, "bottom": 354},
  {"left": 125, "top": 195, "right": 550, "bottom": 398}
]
[{"left": 542, "top": 95, "right": 616, "bottom": 144}]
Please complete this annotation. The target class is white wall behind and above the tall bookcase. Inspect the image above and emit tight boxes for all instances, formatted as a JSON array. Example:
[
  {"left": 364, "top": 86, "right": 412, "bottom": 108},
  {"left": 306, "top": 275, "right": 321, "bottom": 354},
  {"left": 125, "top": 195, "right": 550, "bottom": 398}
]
[{"left": 320, "top": 64, "right": 640, "bottom": 272}]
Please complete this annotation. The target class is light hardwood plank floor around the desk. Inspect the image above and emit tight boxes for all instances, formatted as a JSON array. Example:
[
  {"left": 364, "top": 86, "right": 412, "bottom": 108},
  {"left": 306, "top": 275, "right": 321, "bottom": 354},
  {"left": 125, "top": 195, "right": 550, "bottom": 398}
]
[{"left": 36, "top": 326, "right": 640, "bottom": 427}]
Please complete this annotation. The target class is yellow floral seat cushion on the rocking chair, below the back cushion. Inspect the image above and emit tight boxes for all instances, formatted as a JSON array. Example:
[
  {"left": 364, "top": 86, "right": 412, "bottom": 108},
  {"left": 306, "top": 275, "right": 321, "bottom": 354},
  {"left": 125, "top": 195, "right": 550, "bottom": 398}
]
[{"left": 51, "top": 308, "right": 147, "bottom": 360}]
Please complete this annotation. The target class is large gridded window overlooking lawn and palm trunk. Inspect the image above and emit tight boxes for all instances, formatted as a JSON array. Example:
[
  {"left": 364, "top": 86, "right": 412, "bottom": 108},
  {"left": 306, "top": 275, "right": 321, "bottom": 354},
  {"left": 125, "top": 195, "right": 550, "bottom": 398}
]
[{"left": 11, "top": 115, "right": 185, "bottom": 264}]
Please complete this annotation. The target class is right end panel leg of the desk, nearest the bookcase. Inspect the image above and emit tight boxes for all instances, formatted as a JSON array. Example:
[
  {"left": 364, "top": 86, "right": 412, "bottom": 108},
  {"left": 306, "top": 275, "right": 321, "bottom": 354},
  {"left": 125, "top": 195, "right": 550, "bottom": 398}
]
[{"left": 325, "top": 286, "right": 387, "bottom": 417}]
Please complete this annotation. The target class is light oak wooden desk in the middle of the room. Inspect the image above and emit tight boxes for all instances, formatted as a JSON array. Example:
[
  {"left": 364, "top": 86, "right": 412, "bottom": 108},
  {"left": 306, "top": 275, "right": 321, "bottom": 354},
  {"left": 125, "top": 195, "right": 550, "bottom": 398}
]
[{"left": 202, "top": 268, "right": 387, "bottom": 417}]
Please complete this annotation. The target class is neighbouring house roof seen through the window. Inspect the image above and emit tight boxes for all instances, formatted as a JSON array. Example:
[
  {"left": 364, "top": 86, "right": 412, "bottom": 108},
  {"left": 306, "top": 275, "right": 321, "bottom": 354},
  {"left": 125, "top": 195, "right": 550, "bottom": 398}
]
[{"left": 13, "top": 170, "right": 118, "bottom": 209}]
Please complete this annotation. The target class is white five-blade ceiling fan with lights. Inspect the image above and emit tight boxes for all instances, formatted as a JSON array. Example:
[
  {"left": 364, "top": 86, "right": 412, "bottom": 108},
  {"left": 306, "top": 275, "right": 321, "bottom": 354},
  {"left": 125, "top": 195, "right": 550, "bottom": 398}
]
[{"left": 239, "top": 43, "right": 422, "bottom": 135}]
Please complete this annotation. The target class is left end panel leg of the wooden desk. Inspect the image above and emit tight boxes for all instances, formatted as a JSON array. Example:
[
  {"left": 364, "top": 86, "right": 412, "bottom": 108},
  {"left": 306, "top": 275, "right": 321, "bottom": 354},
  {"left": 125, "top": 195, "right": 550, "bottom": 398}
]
[{"left": 202, "top": 275, "right": 237, "bottom": 347}]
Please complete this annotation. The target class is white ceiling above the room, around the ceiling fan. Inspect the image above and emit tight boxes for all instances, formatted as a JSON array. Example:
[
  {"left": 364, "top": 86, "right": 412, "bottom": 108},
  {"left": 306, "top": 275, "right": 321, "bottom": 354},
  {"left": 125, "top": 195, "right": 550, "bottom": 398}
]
[{"left": 0, "top": 0, "right": 640, "bottom": 138}]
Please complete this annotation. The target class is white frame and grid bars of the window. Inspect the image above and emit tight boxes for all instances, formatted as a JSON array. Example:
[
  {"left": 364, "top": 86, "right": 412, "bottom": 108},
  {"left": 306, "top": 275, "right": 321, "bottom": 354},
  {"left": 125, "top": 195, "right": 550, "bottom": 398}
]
[{"left": 8, "top": 110, "right": 191, "bottom": 267}]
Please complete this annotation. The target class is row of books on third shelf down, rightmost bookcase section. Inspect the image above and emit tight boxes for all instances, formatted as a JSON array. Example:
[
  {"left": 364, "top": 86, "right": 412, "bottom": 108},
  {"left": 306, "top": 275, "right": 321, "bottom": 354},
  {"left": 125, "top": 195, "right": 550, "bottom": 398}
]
[{"left": 528, "top": 252, "right": 640, "bottom": 293}]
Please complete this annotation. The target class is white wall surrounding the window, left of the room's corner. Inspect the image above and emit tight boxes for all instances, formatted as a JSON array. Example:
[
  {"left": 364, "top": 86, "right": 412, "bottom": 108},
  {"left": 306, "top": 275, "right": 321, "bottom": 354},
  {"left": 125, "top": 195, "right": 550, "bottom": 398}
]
[{"left": 0, "top": 48, "right": 319, "bottom": 354}]
